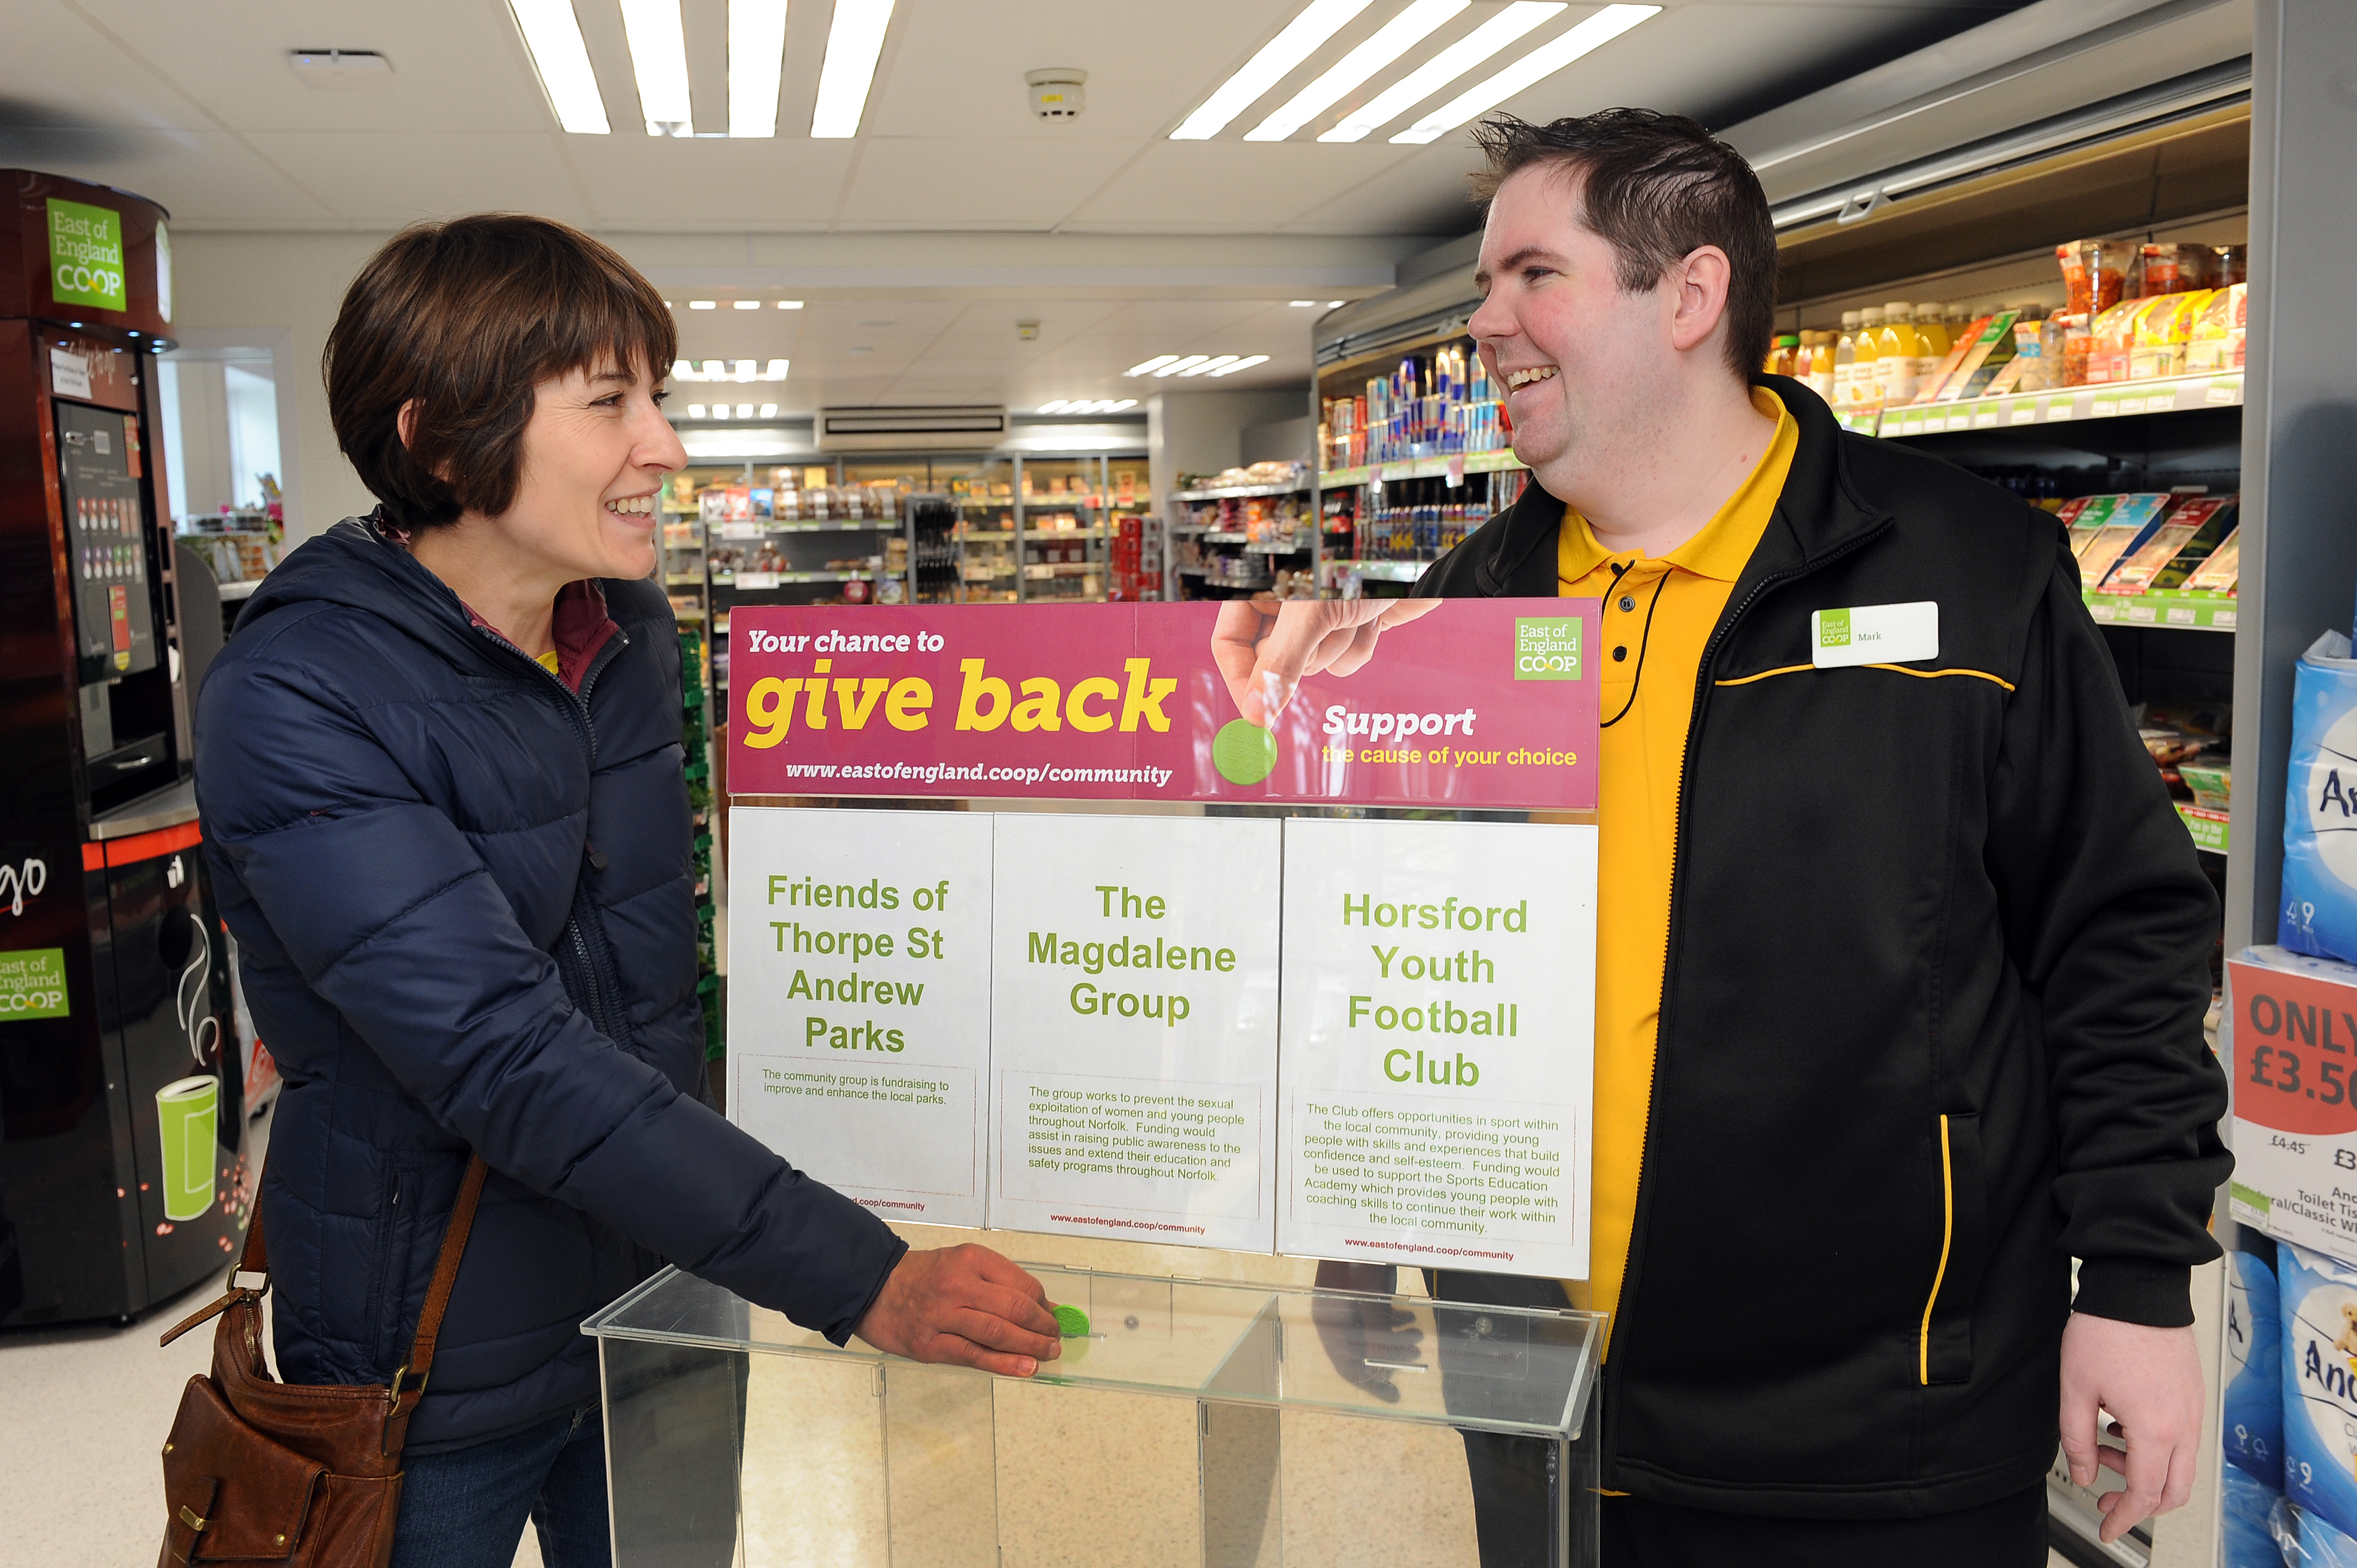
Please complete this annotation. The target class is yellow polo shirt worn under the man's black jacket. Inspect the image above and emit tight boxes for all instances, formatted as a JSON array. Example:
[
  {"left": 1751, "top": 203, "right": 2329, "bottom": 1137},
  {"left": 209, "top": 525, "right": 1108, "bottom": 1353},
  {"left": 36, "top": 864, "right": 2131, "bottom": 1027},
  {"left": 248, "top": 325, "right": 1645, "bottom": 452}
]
[{"left": 1556, "top": 387, "right": 1801, "bottom": 1344}]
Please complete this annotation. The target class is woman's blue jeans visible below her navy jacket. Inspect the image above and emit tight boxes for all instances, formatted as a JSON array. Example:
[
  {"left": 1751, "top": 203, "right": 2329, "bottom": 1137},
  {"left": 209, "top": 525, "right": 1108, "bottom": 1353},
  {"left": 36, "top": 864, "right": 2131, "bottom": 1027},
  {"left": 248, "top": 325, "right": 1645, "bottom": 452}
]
[{"left": 391, "top": 1405, "right": 613, "bottom": 1568}]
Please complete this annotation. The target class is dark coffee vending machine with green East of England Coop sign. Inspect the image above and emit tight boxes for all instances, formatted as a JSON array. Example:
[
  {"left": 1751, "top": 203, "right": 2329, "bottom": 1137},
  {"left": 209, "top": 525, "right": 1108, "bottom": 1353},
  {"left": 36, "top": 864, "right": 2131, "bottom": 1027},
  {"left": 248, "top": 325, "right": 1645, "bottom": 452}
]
[{"left": 0, "top": 170, "right": 252, "bottom": 1325}]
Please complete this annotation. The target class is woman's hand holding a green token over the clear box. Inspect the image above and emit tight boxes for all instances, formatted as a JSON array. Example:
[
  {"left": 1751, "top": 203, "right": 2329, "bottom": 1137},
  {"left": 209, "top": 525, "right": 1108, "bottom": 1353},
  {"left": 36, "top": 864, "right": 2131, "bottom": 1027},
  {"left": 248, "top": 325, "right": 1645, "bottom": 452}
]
[{"left": 851, "top": 1243, "right": 1063, "bottom": 1377}]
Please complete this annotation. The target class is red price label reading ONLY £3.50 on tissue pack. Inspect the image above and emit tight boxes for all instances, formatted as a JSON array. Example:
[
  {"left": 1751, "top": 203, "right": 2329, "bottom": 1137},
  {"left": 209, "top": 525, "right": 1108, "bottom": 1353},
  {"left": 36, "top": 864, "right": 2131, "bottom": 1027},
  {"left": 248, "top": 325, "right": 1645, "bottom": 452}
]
[{"left": 2227, "top": 962, "right": 2357, "bottom": 1134}]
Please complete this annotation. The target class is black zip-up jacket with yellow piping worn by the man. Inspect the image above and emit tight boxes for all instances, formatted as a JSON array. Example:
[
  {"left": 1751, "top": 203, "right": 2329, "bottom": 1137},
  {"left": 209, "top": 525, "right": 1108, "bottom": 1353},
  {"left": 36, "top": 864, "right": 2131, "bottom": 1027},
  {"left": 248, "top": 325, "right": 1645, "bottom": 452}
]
[{"left": 1414, "top": 375, "right": 2232, "bottom": 1518}]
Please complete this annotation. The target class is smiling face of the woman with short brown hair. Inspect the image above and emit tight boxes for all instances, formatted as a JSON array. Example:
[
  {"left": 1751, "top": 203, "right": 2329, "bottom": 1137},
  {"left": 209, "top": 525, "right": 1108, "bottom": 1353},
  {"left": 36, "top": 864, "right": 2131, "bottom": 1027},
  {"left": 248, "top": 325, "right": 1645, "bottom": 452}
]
[{"left": 490, "top": 363, "right": 688, "bottom": 580}]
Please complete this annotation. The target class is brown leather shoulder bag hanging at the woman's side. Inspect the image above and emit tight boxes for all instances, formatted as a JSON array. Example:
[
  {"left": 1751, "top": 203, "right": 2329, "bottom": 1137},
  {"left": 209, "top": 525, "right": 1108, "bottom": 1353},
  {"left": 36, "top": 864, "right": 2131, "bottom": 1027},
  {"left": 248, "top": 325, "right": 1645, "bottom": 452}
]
[{"left": 155, "top": 1156, "right": 488, "bottom": 1568}]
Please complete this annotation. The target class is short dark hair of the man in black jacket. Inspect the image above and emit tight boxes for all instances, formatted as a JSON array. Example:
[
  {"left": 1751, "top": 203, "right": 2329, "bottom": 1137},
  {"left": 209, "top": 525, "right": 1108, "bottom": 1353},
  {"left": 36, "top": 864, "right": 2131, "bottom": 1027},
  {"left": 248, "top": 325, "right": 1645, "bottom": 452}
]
[{"left": 1473, "top": 108, "right": 1777, "bottom": 377}]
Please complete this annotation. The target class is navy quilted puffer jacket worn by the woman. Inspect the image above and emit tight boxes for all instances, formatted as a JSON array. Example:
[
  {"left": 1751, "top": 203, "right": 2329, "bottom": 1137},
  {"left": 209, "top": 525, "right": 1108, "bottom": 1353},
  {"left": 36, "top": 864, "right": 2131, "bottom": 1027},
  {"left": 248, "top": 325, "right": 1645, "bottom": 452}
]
[{"left": 196, "top": 519, "right": 905, "bottom": 1453}]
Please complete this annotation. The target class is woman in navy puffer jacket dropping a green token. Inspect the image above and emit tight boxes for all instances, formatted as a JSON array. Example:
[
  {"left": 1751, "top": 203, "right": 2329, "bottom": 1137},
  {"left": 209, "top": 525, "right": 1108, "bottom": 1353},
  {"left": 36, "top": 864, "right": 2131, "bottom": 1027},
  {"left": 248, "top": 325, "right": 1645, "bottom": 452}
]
[{"left": 196, "top": 217, "right": 1056, "bottom": 1568}]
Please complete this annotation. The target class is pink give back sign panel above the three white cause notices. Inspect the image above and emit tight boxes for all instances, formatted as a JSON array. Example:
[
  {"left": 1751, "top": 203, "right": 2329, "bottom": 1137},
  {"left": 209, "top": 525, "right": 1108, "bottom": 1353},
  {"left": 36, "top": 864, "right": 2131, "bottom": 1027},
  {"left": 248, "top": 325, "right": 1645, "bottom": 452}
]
[{"left": 726, "top": 599, "right": 1601, "bottom": 811}]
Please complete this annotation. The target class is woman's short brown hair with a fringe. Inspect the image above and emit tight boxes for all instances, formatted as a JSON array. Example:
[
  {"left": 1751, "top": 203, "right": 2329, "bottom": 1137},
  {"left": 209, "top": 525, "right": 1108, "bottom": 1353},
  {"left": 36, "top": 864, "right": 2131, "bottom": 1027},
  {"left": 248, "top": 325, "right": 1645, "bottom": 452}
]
[{"left": 323, "top": 212, "right": 679, "bottom": 528}]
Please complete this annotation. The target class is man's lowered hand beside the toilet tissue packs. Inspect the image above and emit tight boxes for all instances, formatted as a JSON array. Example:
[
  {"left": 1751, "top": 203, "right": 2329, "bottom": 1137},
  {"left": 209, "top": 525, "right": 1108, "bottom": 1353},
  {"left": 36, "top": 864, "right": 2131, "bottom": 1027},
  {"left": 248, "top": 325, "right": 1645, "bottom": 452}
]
[{"left": 2062, "top": 1313, "right": 2202, "bottom": 1542}]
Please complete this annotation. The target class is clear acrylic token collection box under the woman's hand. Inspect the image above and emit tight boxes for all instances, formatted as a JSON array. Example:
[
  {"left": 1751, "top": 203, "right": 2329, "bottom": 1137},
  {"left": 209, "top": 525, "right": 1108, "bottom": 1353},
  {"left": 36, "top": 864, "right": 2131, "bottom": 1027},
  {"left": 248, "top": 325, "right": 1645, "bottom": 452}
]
[{"left": 585, "top": 1264, "right": 1603, "bottom": 1568}]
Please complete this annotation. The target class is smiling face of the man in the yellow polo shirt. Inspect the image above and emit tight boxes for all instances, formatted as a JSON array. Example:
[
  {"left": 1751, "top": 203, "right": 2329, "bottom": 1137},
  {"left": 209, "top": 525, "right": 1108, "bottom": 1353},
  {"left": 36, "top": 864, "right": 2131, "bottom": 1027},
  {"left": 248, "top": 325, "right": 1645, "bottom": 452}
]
[{"left": 1468, "top": 165, "right": 1676, "bottom": 488}]
